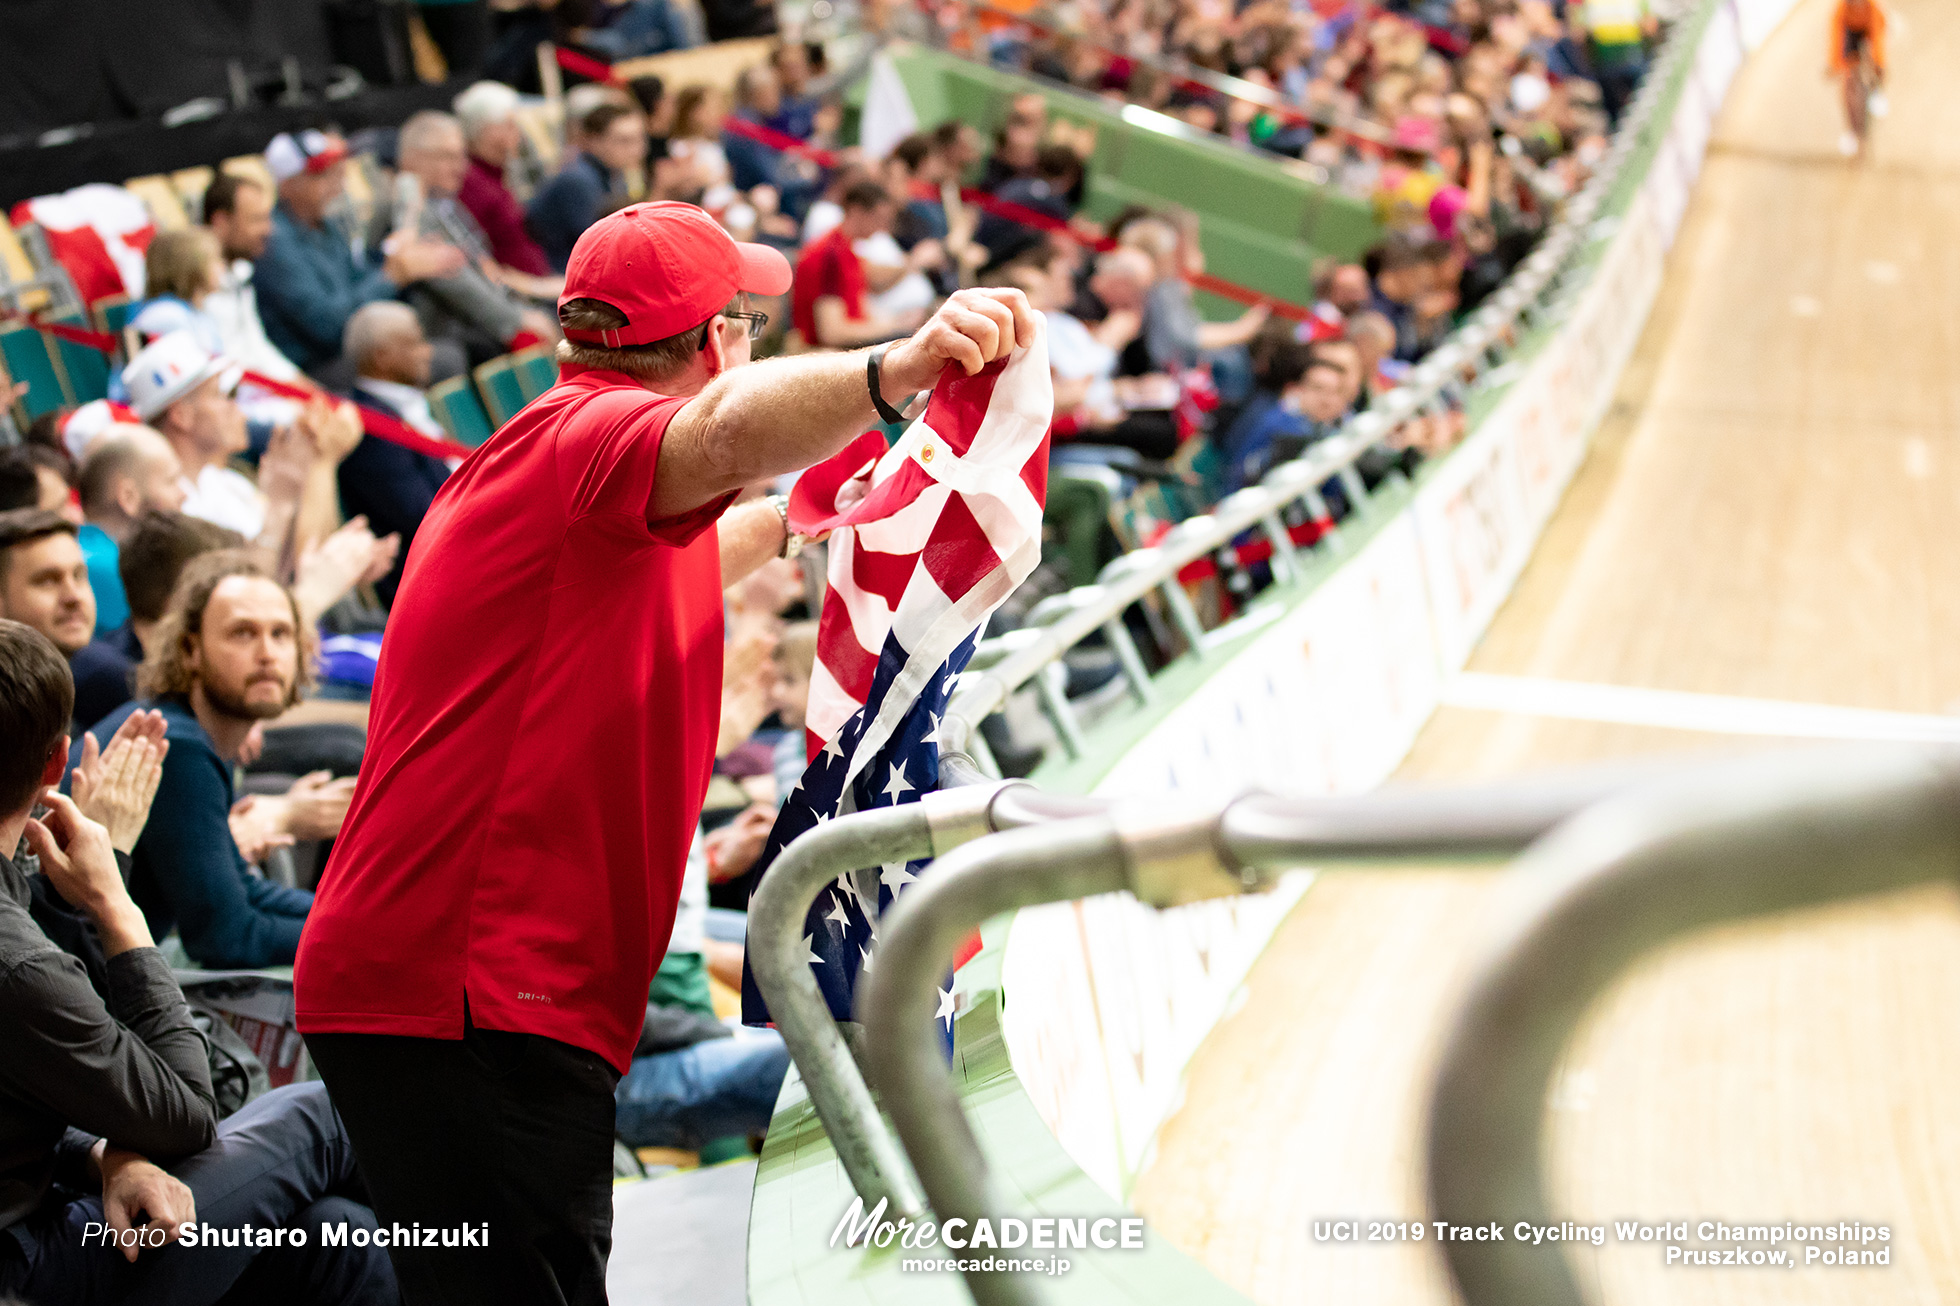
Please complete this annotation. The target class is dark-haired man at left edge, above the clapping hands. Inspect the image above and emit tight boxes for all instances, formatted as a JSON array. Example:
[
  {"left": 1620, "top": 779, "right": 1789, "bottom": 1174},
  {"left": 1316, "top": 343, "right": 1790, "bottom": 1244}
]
[{"left": 0, "top": 508, "right": 117, "bottom": 733}]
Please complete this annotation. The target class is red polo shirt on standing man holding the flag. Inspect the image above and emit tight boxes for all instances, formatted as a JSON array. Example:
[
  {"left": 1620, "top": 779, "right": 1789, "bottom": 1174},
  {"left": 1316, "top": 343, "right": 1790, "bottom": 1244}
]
[{"left": 294, "top": 367, "right": 727, "bottom": 1073}]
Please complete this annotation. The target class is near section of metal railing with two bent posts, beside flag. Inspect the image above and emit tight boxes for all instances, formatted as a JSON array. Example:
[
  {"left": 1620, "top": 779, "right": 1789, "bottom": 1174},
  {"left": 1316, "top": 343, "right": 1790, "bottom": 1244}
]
[{"left": 749, "top": 753, "right": 1716, "bottom": 1306}]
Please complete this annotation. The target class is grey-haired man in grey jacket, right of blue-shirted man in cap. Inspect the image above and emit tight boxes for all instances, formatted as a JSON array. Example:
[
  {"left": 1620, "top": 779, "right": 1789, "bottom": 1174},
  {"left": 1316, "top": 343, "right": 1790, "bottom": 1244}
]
[{"left": 378, "top": 110, "right": 559, "bottom": 365}]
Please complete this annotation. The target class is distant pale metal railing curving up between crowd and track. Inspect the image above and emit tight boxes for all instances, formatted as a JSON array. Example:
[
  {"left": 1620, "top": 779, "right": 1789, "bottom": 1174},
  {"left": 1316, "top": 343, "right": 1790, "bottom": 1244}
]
[{"left": 941, "top": 5, "right": 1693, "bottom": 753}]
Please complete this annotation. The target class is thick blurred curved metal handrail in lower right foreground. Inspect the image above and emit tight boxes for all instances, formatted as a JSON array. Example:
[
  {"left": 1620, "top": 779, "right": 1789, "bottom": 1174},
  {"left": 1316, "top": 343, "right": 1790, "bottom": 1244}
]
[{"left": 1427, "top": 749, "right": 1960, "bottom": 1306}]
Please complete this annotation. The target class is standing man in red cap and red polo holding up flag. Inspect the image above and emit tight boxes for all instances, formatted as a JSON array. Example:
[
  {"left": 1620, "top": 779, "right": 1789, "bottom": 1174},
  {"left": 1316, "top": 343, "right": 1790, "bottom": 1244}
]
[{"left": 294, "top": 204, "right": 1035, "bottom": 1306}]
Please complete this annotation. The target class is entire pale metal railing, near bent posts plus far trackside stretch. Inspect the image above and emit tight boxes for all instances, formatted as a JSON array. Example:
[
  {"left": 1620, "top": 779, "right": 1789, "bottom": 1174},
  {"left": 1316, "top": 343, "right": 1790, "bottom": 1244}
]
[{"left": 749, "top": 12, "right": 1716, "bottom": 1306}]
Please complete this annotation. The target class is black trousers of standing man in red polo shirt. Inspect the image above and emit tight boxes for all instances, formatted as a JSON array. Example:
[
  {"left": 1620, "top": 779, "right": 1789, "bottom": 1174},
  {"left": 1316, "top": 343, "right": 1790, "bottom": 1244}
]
[{"left": 306, "top": 1026, "right": 619, "bottom": 1306}]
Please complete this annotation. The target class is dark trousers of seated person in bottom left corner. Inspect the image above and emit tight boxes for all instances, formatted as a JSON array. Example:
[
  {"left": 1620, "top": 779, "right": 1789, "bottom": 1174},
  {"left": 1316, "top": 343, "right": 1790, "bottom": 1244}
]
[{"left": 0, "top": 1084, "right": 400, "bottom": 1306}]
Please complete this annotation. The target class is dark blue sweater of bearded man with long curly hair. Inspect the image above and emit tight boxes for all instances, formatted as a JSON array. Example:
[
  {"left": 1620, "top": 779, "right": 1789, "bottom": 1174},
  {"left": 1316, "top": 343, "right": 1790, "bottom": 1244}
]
[{"left": 82, "top": 698, "right": 314, "bottom": 969}]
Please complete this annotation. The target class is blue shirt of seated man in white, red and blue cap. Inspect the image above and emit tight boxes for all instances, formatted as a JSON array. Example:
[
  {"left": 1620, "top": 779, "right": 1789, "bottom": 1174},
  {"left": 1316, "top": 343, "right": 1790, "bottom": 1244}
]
[{"left": 253, "top": 204, "right": 396, "bottom": 369}]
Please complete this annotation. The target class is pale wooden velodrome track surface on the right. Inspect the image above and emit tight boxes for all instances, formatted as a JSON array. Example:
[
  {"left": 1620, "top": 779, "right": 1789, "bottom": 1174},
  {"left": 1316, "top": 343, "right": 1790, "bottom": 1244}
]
[{"left": 1135, "top": 0, "right": 1960, "bottom": 1306}]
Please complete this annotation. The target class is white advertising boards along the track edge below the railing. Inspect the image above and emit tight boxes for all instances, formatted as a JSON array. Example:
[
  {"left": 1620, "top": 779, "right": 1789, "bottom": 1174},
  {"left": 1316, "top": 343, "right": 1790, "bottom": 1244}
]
[{"left": 1002, "top": 0, "right": 1789, "bottom": 1198}]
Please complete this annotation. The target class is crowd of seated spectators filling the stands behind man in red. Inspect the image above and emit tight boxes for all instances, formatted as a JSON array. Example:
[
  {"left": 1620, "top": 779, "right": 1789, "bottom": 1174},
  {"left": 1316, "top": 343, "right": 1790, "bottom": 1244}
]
[{"left": 0, "top": 0, "right": 1652, "bottom": 1278}]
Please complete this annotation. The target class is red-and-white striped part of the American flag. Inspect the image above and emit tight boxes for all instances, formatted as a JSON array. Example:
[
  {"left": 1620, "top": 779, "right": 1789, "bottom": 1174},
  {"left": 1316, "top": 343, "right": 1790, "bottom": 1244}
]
[{"left": 790, "top": 314, "right": 1054, "bottom": 772}]
